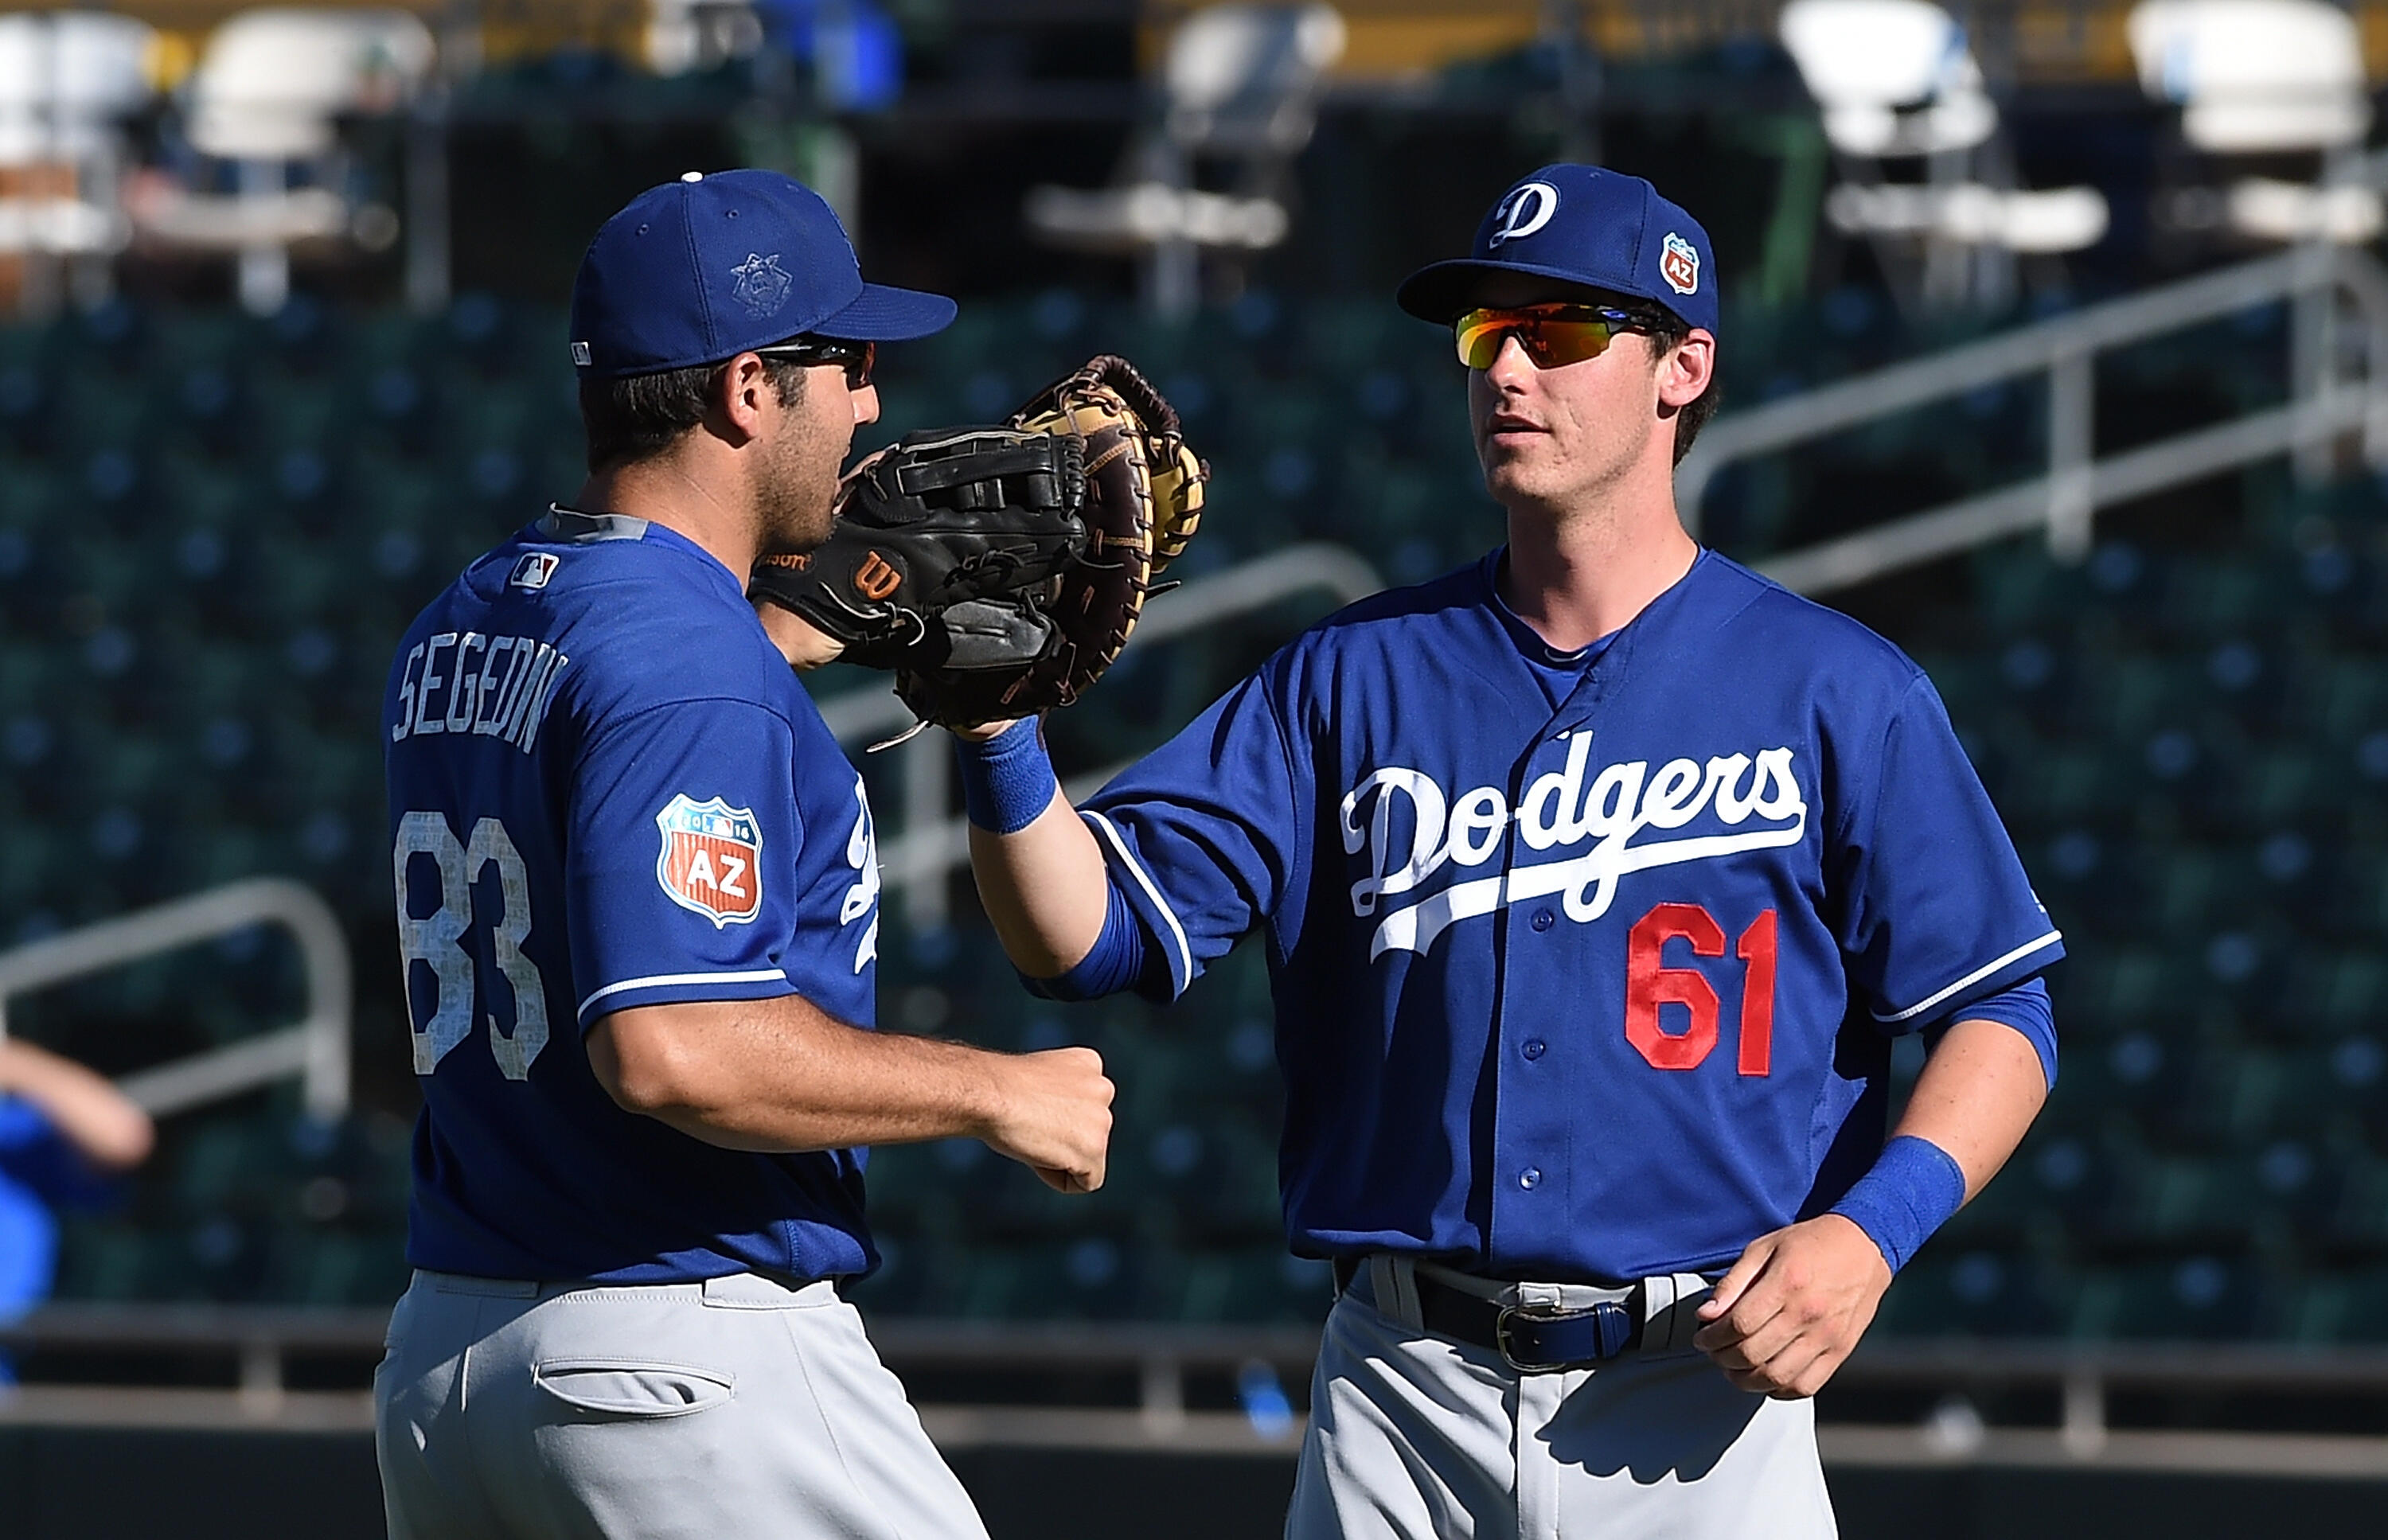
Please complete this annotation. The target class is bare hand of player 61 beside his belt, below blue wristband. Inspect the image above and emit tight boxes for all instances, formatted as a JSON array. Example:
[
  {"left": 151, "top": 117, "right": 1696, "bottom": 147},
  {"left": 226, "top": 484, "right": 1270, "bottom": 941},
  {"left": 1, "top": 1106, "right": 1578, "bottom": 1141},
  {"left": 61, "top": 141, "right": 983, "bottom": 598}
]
[{"left": 1691, "top": 1213, "right": 1891, "bottom": 1399}]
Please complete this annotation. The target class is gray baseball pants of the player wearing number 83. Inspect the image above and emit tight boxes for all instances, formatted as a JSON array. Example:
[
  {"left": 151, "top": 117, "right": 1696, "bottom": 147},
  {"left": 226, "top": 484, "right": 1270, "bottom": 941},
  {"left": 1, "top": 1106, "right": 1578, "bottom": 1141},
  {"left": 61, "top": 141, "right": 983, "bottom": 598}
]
[{"left": 373, "top": 1273, "right": 986, "bottom": 1540}]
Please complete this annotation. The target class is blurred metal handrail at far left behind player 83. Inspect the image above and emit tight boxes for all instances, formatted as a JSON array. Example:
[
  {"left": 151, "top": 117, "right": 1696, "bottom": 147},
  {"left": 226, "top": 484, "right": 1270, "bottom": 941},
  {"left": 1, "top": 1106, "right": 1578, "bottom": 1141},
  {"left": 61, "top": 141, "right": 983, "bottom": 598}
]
[{"left": 0, "top": 876, "right": 353, "bottom": 1117}]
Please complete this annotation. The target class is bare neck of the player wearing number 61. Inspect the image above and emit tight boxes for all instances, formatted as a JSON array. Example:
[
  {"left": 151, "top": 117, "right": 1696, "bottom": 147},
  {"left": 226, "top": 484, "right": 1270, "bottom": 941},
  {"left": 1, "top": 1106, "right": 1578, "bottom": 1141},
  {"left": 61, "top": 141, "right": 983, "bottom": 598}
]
[{"left": 1500, "top": 466, "right": 1700, "bottom": 652}]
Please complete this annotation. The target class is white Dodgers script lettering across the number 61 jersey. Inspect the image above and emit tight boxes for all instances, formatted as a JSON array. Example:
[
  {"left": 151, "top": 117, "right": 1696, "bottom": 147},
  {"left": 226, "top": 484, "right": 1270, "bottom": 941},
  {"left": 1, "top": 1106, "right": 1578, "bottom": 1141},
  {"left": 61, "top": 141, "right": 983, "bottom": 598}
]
[{"left": 1340, "top": 733, "right": 1808, "bottom": 962}]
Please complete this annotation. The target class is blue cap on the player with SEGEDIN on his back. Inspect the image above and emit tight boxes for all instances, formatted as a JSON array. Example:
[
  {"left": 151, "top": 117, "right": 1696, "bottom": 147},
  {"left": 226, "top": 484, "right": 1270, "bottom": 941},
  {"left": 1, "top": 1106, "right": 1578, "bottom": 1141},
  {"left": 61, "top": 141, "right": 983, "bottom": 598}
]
[{"left": 573, "top": 170, "right": 953, "bottom": 380}]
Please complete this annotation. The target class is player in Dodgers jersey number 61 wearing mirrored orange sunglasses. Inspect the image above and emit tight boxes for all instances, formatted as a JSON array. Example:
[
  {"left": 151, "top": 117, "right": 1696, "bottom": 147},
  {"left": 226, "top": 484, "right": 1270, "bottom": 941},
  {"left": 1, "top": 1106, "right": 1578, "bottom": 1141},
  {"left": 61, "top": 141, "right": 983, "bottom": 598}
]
[{"left": 759, "top": 165, "right": 2063, "bottom": 1540}]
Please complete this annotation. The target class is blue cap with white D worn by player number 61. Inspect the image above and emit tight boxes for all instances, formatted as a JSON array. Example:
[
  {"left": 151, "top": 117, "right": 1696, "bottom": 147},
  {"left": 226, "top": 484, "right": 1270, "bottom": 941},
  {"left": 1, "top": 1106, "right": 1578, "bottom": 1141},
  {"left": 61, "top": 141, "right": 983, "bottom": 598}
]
[{"left": 1397, "top": 165, "right": 1717, "bottom": 332}]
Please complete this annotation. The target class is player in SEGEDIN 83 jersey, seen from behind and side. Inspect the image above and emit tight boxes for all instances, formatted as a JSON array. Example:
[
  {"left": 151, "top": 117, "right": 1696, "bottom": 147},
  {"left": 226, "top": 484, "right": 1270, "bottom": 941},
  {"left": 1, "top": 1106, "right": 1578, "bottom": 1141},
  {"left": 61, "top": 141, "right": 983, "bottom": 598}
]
[{"left": 375, "top": 172, "right": 1110, "bottom": 1540}]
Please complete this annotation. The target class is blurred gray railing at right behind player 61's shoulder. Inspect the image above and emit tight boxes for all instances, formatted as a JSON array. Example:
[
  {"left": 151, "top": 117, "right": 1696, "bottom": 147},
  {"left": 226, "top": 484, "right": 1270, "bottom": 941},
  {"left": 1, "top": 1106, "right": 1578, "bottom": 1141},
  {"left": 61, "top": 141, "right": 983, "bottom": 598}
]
[{"left": 1676, "top": 246, "right": 2388, "bottom": 595}]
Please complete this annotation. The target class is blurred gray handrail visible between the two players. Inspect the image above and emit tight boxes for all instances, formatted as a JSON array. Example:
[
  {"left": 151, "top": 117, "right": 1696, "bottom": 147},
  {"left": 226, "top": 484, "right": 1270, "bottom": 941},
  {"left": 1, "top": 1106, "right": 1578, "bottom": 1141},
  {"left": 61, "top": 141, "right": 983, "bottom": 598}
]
[{"left": 821, "top": 544, "right": 1385, "bottom": 912}]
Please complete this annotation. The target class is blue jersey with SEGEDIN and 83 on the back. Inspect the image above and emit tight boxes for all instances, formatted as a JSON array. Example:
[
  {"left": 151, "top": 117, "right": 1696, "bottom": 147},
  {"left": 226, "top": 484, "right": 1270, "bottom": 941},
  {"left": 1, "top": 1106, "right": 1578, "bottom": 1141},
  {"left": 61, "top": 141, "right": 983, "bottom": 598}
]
[{"left": 382, "top": 509, "right": 879, "bottom": 1282}]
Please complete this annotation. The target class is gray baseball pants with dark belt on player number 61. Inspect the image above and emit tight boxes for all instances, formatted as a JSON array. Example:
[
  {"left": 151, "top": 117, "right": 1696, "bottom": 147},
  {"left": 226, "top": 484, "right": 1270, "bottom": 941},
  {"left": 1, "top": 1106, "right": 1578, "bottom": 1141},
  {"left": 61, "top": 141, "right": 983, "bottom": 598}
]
[{"left": 1285, "top": 1258, "right": 1836, "bottom": 1540}]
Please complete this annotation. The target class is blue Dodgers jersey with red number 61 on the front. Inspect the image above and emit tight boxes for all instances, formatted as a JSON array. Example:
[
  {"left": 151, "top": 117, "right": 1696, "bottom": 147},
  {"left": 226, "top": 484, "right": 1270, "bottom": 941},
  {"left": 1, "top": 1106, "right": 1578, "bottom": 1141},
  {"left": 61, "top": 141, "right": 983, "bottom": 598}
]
[{"left": 1087, "top": 552, "right": 2063, "bottom": 1280}]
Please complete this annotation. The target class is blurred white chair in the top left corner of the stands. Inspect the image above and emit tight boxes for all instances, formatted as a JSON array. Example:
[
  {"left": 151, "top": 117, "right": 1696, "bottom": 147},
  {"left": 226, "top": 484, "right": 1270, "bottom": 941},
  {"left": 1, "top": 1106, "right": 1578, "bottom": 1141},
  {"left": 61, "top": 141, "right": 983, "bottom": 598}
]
[{"left": 0, "top": 12, "right": 158, "bottom": 313}]
